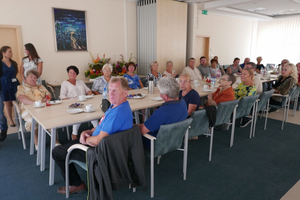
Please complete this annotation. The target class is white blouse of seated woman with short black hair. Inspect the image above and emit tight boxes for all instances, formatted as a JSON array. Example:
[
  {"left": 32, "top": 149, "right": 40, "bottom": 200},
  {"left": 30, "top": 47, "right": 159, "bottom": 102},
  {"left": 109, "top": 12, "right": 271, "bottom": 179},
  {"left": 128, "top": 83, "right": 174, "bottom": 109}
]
[{"left": 60, "top": 80, "right": 90, "bottom": 99}]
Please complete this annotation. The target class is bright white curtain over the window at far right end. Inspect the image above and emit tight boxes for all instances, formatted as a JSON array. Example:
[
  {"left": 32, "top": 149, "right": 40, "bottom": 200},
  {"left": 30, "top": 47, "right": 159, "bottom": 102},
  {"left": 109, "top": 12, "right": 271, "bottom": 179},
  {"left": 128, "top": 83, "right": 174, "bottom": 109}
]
[{"left": 256, "top": 17, "right": 300, "bottom": 64}]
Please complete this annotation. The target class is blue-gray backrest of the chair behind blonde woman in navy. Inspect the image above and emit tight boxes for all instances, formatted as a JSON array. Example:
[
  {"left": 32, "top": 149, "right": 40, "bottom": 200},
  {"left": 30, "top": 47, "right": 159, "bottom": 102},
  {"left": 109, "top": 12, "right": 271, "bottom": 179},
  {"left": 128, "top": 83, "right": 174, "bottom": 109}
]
[{"left": 189, "top": 109, "right": 209, "bottom": 138}]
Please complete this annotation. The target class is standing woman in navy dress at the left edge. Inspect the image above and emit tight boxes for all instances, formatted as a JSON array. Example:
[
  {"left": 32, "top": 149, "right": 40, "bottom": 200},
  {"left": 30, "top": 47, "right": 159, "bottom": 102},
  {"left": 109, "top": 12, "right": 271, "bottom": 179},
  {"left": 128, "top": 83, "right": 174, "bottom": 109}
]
[{"left": 0, "top": 46, "right": 20, "bottom": 127}]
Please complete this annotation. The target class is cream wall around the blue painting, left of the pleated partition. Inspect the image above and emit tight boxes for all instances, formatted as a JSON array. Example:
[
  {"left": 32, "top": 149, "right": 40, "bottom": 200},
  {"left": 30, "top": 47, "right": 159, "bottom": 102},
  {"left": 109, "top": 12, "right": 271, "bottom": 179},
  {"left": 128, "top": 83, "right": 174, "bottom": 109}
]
[{"left": 0, "top": 0, "right": 136, "bottom": 81}]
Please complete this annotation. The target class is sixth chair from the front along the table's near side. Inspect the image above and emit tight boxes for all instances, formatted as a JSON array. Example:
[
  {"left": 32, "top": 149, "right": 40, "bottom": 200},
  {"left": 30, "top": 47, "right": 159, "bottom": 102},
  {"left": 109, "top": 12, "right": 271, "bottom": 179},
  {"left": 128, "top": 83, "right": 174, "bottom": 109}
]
[{"left": 252, "top": 90, "right": 274, "bottom": 137}]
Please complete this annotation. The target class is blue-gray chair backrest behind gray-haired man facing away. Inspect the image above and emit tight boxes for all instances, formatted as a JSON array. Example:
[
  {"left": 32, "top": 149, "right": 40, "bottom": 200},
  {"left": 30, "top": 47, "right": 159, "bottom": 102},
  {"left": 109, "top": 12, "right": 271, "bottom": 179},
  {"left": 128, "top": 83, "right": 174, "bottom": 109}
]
[{"left": 154, "top": 118, "right": 193, "bottom": 157}]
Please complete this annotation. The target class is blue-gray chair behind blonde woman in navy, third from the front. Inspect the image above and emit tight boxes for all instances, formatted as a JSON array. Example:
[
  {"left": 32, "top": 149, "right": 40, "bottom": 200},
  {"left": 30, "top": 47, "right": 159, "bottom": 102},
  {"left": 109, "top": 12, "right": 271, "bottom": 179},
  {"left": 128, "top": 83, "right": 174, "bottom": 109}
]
[{"left": 189, "top": 109, "right": 213, "bottom": 161}]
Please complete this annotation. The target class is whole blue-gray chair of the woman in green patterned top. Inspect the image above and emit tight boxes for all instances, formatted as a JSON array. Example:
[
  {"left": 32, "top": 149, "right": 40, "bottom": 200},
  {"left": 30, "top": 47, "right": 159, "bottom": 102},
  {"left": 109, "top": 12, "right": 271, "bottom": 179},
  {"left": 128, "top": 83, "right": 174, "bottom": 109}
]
[{"left": 231, "top": 94, "right": 259, "bottom": 146}]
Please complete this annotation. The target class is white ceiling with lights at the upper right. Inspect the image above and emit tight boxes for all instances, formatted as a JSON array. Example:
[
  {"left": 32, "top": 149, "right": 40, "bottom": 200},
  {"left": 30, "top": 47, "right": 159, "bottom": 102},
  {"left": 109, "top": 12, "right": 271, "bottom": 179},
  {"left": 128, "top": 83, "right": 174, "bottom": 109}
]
[{"left": 176, "top": 0, "right": 300, "bottom": 20}]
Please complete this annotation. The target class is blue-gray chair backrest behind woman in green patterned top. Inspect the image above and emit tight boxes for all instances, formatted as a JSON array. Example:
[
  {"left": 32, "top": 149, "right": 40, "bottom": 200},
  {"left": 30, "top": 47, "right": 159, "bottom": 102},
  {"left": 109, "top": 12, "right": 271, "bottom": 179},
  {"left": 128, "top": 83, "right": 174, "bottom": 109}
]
[{"left": 235, "top": 94, "right": 259, "bottom": 119}]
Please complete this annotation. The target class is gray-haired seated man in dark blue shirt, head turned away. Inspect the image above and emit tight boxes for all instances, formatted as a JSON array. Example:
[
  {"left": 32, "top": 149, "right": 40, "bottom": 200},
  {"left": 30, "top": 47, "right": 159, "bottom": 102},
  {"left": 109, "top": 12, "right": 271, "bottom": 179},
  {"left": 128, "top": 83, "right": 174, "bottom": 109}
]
[{"left": 138, "top": 76, "right": 188, "bottom": 148}]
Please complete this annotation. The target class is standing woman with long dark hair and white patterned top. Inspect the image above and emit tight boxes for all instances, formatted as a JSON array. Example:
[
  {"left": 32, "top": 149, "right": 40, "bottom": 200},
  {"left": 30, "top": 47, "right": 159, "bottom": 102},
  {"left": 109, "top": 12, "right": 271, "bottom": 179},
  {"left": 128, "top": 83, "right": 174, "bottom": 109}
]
[{"left": 20, "top": 43, "right": 43, "bottom": 85}]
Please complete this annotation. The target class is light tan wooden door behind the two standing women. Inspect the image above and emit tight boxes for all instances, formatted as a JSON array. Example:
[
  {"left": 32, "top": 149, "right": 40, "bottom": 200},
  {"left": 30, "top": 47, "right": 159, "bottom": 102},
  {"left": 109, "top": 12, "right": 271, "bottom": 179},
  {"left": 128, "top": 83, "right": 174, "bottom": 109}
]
[{"left": 0, "top": 25, "right": 24, "bottom": 83}]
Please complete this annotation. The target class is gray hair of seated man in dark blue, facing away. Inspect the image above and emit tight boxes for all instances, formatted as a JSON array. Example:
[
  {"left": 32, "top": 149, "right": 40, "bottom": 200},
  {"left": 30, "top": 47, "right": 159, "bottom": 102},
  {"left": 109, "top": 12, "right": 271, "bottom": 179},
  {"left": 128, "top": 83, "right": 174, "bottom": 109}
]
[{"left": 157, "top": 76, "right": 179, "bottom": 99}]
